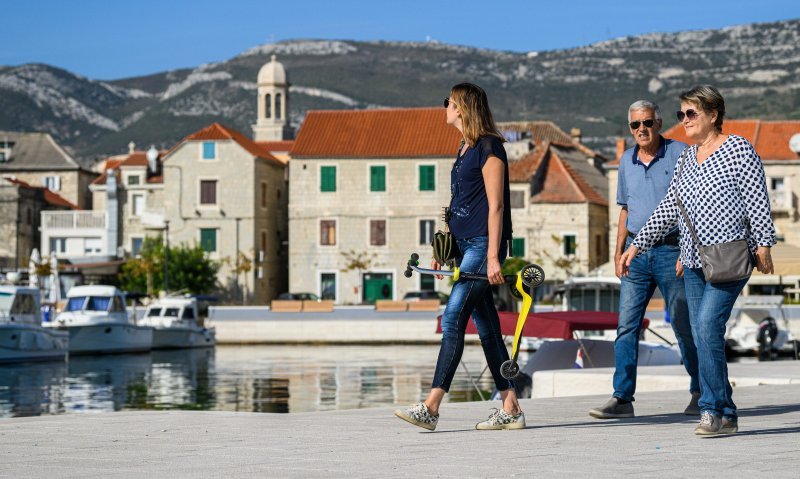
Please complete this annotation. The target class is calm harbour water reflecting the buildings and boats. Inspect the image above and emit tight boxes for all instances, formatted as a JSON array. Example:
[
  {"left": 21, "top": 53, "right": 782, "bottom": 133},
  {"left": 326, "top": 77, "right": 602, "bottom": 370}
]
[{"left": 0, "top": 345, "right": 500, "bottom": 417}]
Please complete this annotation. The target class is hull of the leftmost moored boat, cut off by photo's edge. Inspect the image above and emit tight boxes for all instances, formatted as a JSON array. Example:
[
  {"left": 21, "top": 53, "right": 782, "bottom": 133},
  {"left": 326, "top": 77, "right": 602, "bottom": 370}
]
[{"left": 0, "top": 324, "right": 69, "bottom": 363}]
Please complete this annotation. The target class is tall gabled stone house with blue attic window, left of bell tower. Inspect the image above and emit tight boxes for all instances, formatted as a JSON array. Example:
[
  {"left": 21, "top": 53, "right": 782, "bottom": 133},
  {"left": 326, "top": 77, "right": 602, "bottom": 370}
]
[{"left": 162, "top": 123, "right": 288, "bottom": 304}]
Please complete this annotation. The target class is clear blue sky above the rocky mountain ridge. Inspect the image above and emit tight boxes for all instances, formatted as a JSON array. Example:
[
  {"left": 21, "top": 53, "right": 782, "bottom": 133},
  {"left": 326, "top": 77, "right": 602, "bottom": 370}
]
[{"left": 0, "top": 0, "right": 800, "bottom": 79}]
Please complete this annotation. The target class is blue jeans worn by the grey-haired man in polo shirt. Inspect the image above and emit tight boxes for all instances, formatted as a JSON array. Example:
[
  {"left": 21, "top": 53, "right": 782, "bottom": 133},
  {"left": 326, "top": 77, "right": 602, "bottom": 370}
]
[{"left": 614, "top": 238, "right": 700, "bottom": 401}]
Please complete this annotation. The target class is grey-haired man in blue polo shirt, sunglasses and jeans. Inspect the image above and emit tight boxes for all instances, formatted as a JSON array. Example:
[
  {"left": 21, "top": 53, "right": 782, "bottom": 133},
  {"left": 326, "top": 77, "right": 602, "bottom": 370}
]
[{"left": 589, "top": 100, "right": 700, "bottom": 419}]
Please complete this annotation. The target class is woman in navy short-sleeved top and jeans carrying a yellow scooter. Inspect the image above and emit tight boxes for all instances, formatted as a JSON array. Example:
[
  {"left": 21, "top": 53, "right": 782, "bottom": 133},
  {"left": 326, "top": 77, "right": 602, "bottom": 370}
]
[{"left": 395, "top": 83, "right": 525, "bottom": 431}]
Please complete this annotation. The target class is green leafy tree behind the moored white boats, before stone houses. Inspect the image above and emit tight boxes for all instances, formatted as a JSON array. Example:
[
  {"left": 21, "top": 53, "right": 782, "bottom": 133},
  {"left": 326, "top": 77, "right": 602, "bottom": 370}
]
[{"left": 119, "top": 236, "right": 219, "bottom": 295}]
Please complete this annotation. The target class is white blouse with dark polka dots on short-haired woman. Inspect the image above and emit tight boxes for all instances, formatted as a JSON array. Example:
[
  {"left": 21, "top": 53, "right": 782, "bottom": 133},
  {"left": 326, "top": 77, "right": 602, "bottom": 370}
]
[{"left": 633, "top": 135, "right": 775, "bottom": 268}]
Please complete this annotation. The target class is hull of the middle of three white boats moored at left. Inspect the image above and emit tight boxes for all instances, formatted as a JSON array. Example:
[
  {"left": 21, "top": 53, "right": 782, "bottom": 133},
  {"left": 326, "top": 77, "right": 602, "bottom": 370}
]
[{"left": 67, "top": 323, "right": 153, "bottom": 354}]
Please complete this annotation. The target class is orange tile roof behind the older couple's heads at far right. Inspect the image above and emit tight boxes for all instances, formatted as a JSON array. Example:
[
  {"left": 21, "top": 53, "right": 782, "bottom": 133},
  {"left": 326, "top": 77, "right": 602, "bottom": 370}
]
[{"left": 664, "top": 120, "right": 800, "bottom": 161}]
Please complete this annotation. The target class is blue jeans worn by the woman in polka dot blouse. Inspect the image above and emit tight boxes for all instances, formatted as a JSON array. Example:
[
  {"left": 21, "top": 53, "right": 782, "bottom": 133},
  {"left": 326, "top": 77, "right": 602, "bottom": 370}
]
[{"left": 684, "top": 268, "right": 748, "bottom": 419}]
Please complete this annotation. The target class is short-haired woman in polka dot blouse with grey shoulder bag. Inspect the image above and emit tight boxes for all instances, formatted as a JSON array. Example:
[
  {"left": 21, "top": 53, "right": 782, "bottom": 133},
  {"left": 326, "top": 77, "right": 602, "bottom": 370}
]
[{"left": 619, "top": 85, "right": 775, "bottom": 436}]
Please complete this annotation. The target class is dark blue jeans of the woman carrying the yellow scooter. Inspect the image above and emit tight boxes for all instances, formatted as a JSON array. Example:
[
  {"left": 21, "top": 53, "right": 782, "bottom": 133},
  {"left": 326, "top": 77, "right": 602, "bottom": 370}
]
[{"left": 431, "top": 236, "right": 513, "bottom": 391}]
